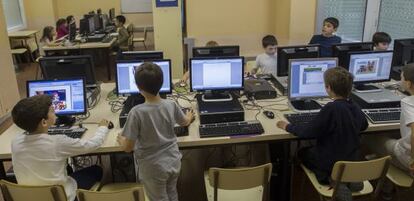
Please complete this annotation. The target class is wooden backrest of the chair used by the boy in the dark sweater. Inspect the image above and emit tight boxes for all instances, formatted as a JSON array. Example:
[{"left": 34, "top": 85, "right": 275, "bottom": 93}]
[{"left": 331, "top": 156, "right": 391, "bottom": 182}]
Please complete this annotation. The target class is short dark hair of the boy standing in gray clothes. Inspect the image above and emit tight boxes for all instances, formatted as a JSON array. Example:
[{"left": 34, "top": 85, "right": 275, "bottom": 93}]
[{"left": 135, "top": 62, "right": 164, "bottom": 96}]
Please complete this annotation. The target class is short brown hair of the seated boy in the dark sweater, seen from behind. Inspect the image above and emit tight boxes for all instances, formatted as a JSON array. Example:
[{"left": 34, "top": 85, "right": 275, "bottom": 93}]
[{"left": 323, "top": 67, "right": 354, "bottom": 98}]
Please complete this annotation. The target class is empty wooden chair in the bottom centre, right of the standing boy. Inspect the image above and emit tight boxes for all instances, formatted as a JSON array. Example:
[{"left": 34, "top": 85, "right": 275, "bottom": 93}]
[{"left": 204, "top": 163, "right": 272, "bottom": 201}]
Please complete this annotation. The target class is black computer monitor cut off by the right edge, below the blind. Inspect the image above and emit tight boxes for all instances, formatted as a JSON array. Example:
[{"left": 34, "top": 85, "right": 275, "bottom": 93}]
[{"left": 392, "top": 38, "right": 414, "bottom": 66}]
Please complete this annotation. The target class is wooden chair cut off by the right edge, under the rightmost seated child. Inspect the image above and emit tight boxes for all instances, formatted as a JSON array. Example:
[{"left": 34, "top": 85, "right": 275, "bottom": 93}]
[{"left": 387, "top": 164, "right": 413, "bottom": 200}]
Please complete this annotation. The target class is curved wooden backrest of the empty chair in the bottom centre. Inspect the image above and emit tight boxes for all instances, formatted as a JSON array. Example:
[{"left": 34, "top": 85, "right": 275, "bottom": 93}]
[{"left": 208, "top": 163, "right": 272, "bottom": 190}]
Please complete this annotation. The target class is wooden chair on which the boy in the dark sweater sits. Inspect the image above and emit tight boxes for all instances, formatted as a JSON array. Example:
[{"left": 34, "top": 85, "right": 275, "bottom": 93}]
[{"left": 301, "top": 156, "right": 391, "bottom": 201}]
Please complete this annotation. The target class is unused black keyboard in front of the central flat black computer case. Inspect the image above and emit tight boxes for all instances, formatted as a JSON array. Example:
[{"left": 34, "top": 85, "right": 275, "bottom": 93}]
[{"left": 199, "top": 121, "right": 264, "bottom": 138}]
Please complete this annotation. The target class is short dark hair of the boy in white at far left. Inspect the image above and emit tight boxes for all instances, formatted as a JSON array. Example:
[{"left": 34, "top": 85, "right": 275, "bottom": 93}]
[{"left": 12, "top": 95, "right": 52, "bottom": 133}]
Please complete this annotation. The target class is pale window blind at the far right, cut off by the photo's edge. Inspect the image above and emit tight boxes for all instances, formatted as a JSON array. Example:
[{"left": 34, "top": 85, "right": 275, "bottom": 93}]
[{"left": 378, "top": 0, "right": 414, "bottom": 39}]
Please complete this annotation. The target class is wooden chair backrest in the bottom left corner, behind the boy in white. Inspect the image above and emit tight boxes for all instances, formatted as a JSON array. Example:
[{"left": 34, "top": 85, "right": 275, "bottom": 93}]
[{"left": 0, "top": 180, "right": 67, "bottom": 201}]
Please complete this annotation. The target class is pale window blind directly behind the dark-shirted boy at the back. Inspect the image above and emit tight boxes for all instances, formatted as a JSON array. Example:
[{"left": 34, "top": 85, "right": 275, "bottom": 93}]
[{"left": 316, "top": 0, "right": 367, "bottom": 42}]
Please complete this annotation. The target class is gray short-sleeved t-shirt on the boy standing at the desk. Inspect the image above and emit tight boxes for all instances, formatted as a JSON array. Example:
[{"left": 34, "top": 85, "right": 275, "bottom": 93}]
[{"left": 122, "top": 99, "right": 185, "bottom": 165}]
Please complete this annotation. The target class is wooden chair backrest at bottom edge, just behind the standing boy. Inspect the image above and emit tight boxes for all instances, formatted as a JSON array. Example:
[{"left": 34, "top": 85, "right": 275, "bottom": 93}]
[{"left": 77, "top": 187, "right": 145, "bottom": 201}]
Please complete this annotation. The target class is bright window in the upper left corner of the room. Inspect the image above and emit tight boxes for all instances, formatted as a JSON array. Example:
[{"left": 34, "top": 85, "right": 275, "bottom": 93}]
[{"left": 1, "top": 0, "right": 26, "bottom": 32}]
